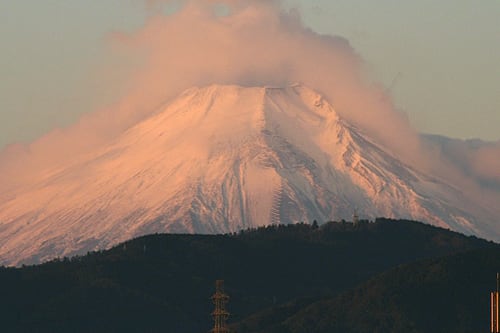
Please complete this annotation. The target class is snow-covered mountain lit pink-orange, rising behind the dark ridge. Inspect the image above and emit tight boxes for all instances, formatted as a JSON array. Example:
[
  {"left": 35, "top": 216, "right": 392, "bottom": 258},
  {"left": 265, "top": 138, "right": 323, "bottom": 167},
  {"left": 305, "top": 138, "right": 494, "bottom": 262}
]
[{"left": 0, "top": 85, "right": 500, "bottom": 264}]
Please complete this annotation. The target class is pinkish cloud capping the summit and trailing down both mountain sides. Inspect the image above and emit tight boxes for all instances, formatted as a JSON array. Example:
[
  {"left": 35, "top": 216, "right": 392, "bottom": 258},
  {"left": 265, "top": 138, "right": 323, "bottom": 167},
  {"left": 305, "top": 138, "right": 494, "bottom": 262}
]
[{"left": 0, "top": 0, "right": 500, "bottom": 200}]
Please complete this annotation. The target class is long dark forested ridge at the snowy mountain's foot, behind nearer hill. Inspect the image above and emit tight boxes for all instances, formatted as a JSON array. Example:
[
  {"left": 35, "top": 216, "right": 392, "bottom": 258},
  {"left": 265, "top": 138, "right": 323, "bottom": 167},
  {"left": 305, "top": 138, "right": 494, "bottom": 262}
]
[{"left": 0, "top": 219, "right": 500, "bottom": 333}]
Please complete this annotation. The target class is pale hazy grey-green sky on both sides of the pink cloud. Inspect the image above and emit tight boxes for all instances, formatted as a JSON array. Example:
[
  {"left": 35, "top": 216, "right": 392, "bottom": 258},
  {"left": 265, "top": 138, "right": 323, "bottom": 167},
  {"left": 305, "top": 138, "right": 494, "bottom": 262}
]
[{"left": 0, "top": 0, "right": 500, "bottom": 147}]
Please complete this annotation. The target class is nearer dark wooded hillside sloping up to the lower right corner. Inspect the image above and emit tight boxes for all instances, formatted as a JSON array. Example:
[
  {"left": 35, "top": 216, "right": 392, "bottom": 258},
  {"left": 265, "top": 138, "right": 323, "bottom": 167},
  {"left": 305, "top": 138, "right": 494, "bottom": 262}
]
[{"left": 233, "top": 248, "right": 500, "bottom": 333}]
